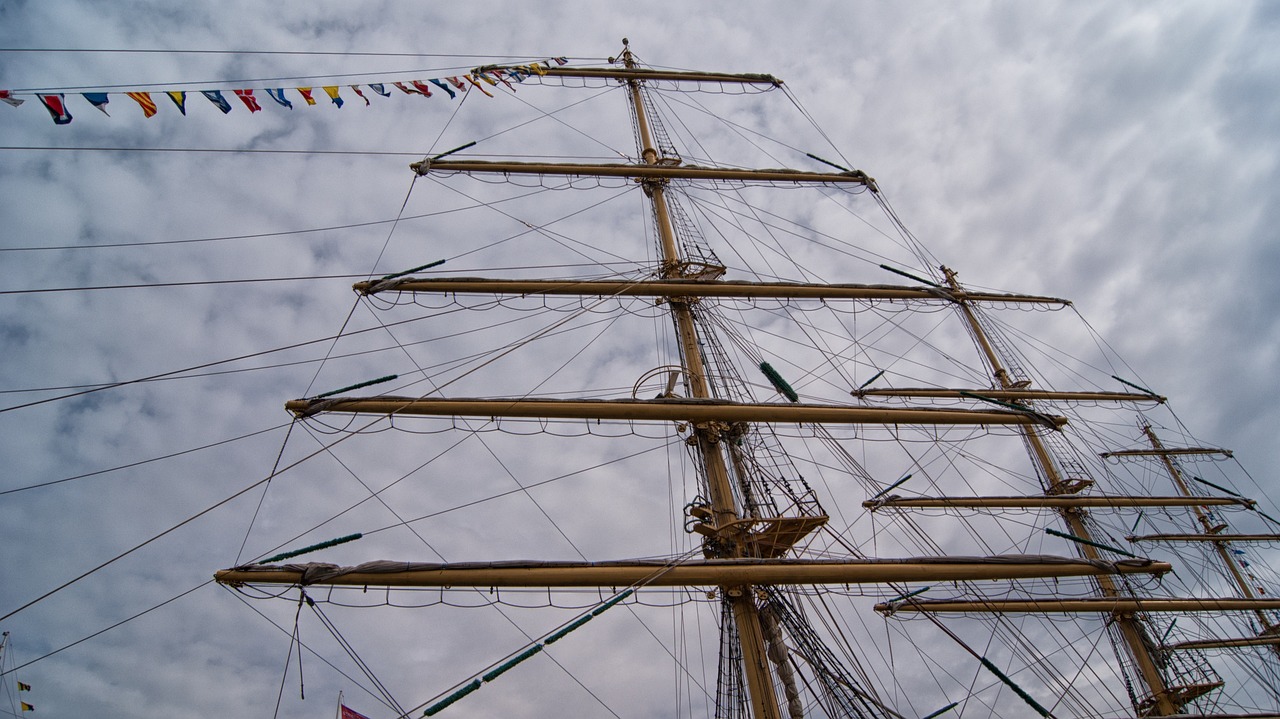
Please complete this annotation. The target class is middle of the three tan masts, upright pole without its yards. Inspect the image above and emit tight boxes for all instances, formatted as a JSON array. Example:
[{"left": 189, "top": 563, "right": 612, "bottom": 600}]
[{"left": 942, "top": 267, "right": 1180, "bottom": 716}]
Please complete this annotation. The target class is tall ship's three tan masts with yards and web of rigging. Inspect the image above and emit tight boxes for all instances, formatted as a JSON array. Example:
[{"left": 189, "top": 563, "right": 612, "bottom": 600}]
[{"left": 199, "top": 41, "right": 1280, "bottom": 719}]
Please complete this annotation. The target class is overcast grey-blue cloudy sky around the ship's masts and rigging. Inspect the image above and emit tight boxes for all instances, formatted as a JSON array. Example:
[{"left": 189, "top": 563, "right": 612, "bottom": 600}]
[{"left": 0, "top": 0, "right": 1280, "bottom": 719}]
